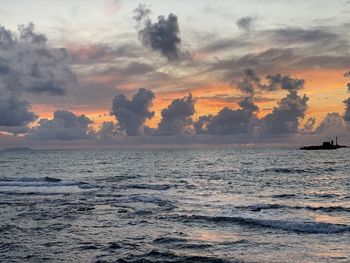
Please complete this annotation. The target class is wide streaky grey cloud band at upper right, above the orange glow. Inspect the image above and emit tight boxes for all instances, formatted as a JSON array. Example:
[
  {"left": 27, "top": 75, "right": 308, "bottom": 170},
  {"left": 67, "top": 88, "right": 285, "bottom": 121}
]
[{"left": 208, "top": 24, "right": 350, "bottom": 81}]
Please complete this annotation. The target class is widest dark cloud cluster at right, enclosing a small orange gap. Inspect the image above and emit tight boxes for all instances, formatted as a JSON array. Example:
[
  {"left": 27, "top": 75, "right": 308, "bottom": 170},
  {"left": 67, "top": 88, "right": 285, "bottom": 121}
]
[{"left": 194, "top": 69, "right": 308, "bottom": 135}]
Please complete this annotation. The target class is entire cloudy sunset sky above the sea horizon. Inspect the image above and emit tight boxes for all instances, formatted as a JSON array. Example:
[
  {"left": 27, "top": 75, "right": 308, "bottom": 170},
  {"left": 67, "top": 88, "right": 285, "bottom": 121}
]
[{"left": 0, "top": 0, "right": 350, "bottom": 148}]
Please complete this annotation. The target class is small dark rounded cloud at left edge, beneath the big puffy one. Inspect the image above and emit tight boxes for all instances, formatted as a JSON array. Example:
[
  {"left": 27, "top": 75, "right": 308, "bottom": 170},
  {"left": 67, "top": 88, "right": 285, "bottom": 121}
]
[{"left": 0, "top": 92, "right": 37, "bottom": 130}]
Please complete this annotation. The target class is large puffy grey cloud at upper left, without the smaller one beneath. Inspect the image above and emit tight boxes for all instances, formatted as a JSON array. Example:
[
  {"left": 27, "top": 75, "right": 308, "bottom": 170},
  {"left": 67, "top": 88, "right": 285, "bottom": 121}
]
[{"left": 0, "top": 23, "right": 75, "bottom": 95}]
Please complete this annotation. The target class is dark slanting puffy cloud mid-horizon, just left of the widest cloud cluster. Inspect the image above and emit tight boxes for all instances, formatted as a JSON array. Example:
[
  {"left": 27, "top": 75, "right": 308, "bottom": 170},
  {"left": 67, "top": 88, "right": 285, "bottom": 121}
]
[{"left": 156, "top": 94, "right": 195, "bottom": 135}]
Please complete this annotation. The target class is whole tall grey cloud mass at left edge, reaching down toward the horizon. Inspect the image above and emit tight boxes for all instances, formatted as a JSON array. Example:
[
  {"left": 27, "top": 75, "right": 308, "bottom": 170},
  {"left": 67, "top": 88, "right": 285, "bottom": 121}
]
[{"left": 0, "top": 23, "right": 75, "bottom": 133}]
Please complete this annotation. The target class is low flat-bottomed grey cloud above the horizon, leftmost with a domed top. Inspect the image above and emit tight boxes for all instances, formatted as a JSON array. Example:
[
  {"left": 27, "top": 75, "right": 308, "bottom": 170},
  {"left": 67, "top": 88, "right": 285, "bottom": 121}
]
[{"left": 29, "top": 110, "right": 93, "bottom": 141}]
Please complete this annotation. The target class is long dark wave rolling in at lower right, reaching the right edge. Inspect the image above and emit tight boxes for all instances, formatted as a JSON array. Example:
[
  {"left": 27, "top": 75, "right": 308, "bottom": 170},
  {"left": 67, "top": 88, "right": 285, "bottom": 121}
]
[{"left": 180, "top": 215, "right": 350, "bottom": 234}]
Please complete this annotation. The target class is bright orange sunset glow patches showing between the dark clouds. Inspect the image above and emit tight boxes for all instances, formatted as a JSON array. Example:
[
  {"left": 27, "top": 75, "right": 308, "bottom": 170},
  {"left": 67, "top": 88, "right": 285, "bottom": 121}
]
[{"left": 32, "top": 69, "right": 348, "bottom": 128}]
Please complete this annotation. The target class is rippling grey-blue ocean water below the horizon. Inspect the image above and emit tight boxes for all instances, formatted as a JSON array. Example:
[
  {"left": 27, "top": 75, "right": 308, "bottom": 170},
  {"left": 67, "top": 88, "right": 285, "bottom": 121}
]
[{"left": 0, "top": 148, "right": 350, "bottom": 262}]
